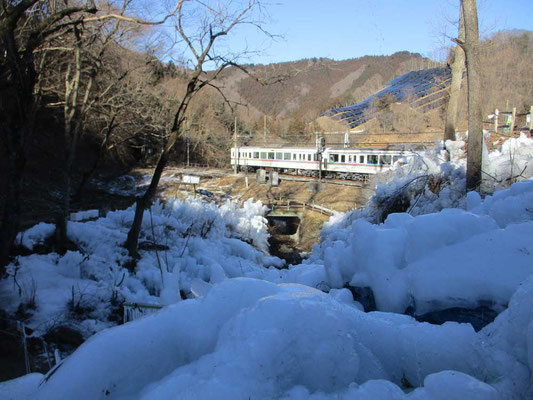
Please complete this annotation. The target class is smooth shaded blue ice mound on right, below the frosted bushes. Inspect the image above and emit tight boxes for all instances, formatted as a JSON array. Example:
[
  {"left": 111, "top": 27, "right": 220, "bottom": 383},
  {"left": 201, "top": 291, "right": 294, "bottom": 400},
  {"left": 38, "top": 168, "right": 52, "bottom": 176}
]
[{"left": 282, "top": 181, "right": 533, "bottom": 314}]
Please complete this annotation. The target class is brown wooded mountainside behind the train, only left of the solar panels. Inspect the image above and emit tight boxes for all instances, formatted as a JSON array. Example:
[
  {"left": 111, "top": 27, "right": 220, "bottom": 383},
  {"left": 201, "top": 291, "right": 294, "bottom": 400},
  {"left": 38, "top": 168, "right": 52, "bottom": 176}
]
[{"left": 220, "top": 52, "right": 437, "bottom": 134}]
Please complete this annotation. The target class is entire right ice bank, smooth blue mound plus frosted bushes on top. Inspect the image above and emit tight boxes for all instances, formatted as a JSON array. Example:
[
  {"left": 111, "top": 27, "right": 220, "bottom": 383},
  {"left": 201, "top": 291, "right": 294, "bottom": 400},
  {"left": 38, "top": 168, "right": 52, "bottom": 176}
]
[{"left": 274, "top": 135, "right": 533, "bottom": 314}]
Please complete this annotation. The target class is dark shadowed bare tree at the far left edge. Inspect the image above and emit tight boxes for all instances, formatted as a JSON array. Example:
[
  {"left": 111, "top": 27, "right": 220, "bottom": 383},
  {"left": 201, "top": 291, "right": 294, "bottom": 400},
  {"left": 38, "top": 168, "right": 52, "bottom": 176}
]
[{"left": 0, "top": 0, "right": 96, "bottom": 276}]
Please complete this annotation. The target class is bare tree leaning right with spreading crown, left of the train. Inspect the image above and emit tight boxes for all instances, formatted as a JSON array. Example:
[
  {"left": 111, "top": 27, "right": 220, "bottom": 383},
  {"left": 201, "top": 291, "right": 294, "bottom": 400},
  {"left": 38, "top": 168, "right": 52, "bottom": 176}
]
[{"left": 124, "top": 0, "right": 261, "bottom": 257}]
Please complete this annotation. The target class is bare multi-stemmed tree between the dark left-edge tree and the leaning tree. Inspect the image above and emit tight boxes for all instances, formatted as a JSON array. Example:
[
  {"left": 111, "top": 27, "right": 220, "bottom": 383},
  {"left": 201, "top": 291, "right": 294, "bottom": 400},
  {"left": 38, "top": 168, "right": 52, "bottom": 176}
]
[{"left": 50, "top": 0, "right": 148, "bottom": 252}]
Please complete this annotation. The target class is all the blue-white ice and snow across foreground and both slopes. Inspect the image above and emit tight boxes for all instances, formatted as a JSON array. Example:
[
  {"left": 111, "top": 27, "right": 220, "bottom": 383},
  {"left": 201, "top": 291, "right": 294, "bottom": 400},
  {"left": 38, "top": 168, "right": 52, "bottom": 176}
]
[{"left": 0, "top": 133, "right": 533, "bottom": 400}]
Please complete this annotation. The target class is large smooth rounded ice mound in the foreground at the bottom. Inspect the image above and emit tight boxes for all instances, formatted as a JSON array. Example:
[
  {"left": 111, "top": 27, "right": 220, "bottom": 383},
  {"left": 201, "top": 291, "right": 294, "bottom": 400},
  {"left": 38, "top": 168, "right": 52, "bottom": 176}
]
[{"left": 32, "top": 278, "right": 506, "bottom": 399}]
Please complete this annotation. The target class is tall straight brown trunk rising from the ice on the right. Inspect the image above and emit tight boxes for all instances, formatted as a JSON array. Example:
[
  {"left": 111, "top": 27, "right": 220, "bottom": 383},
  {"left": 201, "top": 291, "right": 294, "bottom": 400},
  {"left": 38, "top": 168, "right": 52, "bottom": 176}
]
[{"left": 461, "top": 0, "right": 483, "bottom": 190}]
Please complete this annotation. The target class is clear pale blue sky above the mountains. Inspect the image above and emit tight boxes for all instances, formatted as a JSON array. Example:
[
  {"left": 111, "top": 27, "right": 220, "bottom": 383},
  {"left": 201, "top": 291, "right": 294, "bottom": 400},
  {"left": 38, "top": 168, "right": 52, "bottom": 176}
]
[{"left": 221, "top": 0, "right": 533, "bottom": 64}]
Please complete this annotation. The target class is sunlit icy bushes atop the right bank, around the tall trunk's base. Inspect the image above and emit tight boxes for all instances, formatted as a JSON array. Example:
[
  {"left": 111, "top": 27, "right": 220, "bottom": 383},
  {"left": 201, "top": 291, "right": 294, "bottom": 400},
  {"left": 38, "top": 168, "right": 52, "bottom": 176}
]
[{"left": 324, "top": 134, "right": 533, "bottom": 228}]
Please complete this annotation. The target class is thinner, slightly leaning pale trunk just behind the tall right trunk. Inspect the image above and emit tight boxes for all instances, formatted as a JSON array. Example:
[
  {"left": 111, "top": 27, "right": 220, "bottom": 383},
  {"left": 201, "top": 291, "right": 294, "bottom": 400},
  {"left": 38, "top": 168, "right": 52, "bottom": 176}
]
[{"left": 444, "top": 7, "right": 465, "bottom": 142}]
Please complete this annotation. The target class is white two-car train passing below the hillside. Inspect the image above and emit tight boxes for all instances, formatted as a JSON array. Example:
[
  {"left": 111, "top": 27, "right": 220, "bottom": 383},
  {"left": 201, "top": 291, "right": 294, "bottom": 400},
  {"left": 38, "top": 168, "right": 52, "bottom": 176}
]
[{"left": 231, "top": 146, "right": 412, "bottom": 180}]
